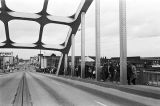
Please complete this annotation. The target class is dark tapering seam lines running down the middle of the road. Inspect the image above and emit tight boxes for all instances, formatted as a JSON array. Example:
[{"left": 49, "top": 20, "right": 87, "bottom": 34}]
[{"left": 12, "top": 72, "right": 33, "bottom": 106}]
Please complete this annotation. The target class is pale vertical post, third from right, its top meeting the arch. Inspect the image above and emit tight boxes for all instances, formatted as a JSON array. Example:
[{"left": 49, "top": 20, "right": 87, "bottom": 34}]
[{"left": 81, "top": 12, "right": 85, "bottom": 78}]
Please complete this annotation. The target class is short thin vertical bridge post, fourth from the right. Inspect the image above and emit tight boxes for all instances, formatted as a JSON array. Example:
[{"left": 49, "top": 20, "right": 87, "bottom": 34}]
[{"left": 71, "top": 34, "right": 75, "bottom": 76}]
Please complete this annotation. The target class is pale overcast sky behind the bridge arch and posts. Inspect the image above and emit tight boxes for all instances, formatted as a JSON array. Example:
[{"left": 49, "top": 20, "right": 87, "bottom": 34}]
[{"left": 0, "top": 0, "right": 160, "bottom": 59}]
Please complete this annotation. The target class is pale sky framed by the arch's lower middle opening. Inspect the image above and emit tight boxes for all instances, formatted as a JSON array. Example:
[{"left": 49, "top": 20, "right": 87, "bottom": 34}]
[{"left": 9, "top": 20, "right": 40, "bottom": 43}]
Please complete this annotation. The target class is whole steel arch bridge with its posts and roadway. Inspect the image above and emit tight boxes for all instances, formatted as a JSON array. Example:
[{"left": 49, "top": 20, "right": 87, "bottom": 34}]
[{"left": 0, "top": 0, "right": 160, "bottom": 106}]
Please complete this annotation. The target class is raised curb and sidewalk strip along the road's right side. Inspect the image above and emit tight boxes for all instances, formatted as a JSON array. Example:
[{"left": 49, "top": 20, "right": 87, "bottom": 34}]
[{"left": 60, "top": 76, "right": 160, "bottom": 99}]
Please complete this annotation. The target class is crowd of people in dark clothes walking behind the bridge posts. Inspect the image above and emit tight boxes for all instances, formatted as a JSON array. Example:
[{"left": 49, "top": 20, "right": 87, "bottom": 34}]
[{"left": 67, "top": 62, "right": 137, "bottom": 85}]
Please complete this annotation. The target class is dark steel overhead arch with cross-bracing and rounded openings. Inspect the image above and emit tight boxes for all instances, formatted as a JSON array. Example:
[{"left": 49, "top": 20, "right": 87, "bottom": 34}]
[{"left": 0, "top": 0, "right": 93, "bottom": 53}]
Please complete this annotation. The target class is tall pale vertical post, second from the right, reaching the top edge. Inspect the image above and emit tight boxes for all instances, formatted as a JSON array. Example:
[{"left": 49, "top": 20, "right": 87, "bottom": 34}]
[{"left": 95, "top": 0, "right": 100, "bottom": 81}]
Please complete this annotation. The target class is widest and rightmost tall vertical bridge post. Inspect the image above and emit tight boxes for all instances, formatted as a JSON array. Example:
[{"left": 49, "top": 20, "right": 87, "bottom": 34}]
[{"left": 119, "top": 0, "right": 127, "bottom": 85}]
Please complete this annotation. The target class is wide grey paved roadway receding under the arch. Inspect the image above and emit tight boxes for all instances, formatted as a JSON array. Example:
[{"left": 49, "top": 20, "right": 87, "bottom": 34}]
[{"left": 0, "top": 67, "right": 160, "bottom": 106}]
